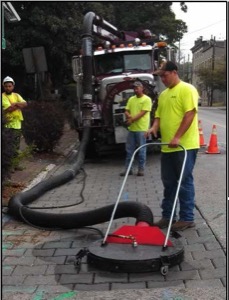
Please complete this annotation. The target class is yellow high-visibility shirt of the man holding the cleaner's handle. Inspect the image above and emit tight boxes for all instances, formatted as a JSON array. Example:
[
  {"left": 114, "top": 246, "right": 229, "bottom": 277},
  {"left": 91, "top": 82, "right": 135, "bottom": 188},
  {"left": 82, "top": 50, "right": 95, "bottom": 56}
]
[{"left": 155, "top": 81, "right": 199, "bottom": 152}]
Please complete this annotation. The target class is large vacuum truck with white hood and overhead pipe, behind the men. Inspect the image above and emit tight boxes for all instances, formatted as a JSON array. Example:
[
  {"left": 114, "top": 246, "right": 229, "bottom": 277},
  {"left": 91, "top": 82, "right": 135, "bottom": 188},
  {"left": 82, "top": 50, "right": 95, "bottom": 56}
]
[{"left": 72, "top": 12, "right": 175, "bottom": 154}]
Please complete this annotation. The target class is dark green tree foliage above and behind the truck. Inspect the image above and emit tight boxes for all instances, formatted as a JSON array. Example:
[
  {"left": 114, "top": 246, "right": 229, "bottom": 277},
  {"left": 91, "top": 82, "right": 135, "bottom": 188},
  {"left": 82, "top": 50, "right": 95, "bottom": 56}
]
[{"left": 2, "top": 1, "right": 187, "bottom": 86}]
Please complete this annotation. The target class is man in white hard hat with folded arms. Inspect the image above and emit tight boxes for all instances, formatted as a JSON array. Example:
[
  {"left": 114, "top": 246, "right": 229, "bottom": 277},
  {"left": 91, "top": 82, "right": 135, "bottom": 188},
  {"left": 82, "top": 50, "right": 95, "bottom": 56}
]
[{"left": 2, "top": 76, "right": 27, "bottom": 161}]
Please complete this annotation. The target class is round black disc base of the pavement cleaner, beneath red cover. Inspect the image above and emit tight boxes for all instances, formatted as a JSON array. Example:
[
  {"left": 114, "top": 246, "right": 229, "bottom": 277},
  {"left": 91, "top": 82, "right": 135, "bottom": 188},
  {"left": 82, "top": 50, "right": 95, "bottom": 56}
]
[{"left": 87, "top": 238, "right": 184, "bottom": 275}]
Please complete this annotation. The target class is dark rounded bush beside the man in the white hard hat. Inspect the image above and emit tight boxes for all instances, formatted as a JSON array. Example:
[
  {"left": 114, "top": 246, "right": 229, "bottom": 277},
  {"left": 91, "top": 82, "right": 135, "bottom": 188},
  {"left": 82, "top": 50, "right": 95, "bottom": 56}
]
[{"left": 22, "top": 101, "right": 64, "bottom": 152}]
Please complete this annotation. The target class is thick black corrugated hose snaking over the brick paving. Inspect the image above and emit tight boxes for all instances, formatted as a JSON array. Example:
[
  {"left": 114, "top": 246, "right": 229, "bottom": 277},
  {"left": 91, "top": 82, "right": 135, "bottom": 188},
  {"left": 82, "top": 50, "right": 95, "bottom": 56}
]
[{"left": 8, "top": 128, "right": 153, "bottom": 229}]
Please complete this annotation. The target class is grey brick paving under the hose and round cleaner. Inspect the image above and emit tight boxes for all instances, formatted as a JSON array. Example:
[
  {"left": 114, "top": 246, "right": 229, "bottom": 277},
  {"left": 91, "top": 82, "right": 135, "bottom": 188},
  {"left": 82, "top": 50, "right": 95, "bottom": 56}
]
[{"left": 2, "top": 131, "right": 226, "bottom": 300}]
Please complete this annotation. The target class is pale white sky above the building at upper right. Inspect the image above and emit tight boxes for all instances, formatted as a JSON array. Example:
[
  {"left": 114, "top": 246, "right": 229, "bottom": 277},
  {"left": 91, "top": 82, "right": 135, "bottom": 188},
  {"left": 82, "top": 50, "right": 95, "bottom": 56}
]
[{"left": 172, "top": 1, "right": 227, "bottom": 61}]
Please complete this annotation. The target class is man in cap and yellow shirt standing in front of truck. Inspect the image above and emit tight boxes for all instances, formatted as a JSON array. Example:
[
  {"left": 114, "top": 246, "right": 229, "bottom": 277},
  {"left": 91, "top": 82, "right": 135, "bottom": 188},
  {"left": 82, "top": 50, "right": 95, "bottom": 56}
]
[{"left": 120, "top": 81, "right": 152, "bottom": 176}]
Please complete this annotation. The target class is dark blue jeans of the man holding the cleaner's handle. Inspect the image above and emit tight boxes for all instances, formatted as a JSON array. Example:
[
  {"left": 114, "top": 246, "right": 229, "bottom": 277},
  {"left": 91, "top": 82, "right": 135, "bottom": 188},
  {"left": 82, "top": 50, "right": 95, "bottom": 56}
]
[{"left": 161, "top": 149, "right": 198, "bottom": 221}]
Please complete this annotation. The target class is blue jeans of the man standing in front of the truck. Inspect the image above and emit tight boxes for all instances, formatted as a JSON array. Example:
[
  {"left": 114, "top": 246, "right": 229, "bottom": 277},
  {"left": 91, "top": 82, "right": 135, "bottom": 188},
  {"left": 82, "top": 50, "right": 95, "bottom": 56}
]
[{"left": 125, "top": 131, "right": 146, "bottom": 170}]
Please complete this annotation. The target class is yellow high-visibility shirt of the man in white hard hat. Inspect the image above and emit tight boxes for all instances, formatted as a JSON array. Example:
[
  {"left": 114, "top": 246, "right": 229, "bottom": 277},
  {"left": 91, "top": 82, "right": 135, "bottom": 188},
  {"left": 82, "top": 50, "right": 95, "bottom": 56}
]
[{"left": 2, "top": 93, "right": 26, "bottom": 129}]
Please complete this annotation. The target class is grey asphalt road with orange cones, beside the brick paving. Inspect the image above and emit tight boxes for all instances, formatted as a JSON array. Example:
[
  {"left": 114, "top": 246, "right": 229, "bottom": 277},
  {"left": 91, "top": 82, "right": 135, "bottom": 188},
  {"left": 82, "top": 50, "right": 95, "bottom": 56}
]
[{"left": 194, "top": 107, "right": 227, "bottom": 249}]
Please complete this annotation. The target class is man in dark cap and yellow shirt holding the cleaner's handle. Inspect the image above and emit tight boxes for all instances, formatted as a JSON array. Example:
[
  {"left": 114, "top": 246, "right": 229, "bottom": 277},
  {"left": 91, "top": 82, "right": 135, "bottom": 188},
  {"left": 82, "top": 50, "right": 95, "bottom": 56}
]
[{"left": 146, "top": 61, "right": 199, "bottom": 231}]
